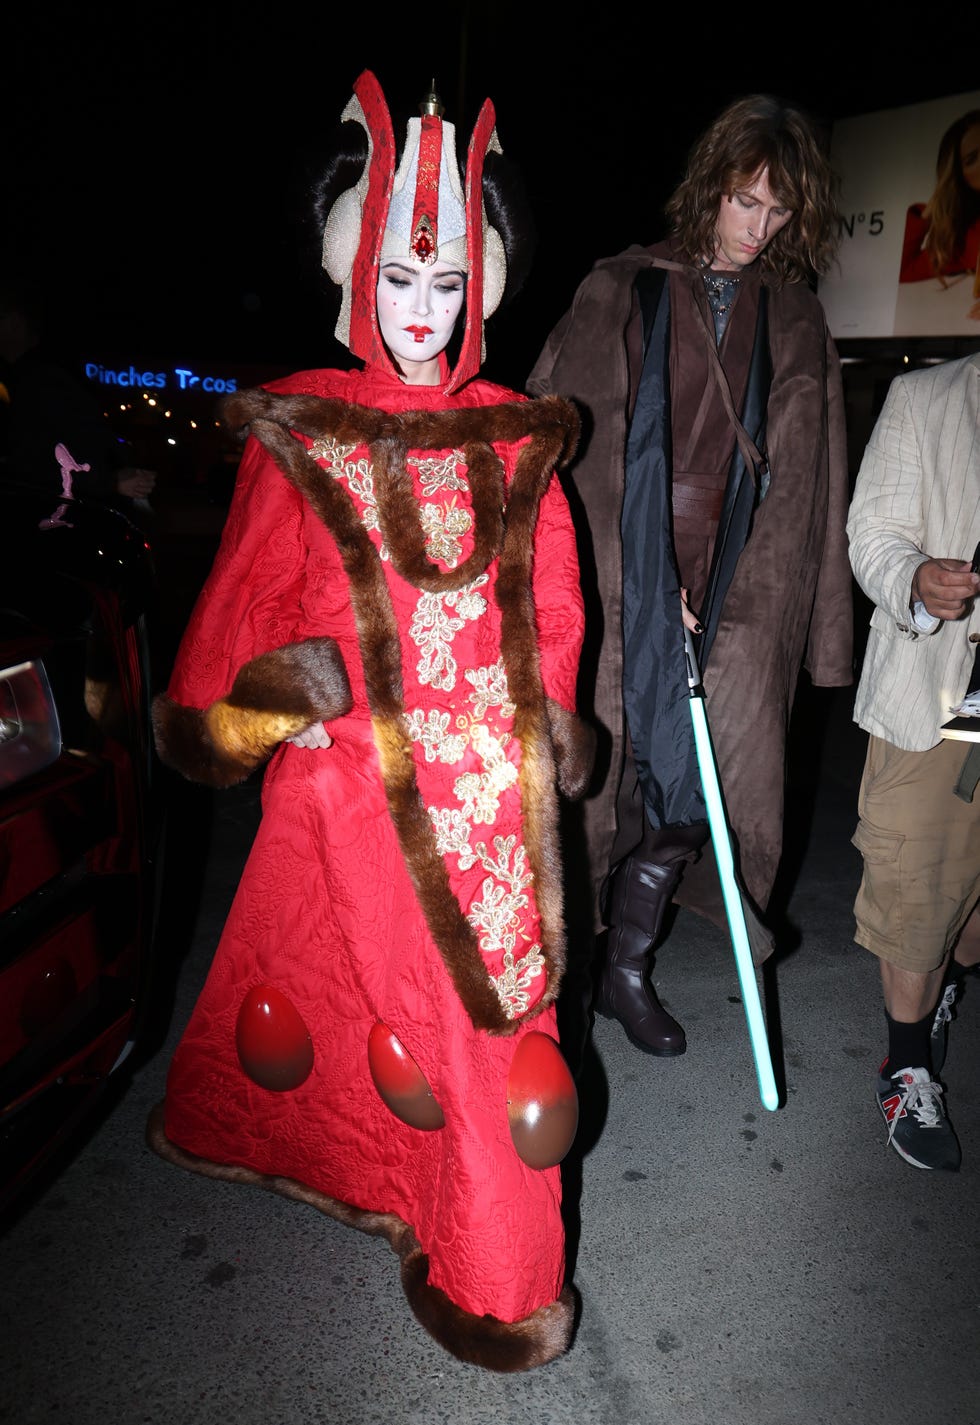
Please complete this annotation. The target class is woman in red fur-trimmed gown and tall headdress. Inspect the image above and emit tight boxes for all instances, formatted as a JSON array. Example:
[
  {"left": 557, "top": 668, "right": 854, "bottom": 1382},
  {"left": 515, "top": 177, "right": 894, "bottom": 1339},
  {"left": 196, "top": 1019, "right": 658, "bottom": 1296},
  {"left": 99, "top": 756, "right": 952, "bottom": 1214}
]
[{"left": 148, "top": 73, "right": 591, "bottom": 1371}]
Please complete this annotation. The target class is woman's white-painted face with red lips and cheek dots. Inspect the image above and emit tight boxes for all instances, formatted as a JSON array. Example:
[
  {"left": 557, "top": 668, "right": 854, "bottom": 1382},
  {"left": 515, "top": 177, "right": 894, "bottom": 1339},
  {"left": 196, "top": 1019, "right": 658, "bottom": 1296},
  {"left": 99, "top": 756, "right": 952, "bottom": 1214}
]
[{"left": 377, "top": 257, "right": 466, "bottom": 386}]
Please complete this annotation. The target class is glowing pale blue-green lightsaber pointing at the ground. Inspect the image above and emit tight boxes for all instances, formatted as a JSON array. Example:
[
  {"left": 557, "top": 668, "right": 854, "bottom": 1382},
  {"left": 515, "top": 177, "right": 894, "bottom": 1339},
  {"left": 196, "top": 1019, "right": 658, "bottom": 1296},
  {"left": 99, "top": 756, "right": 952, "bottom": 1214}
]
[{"left": 684, "top": 627, "right": 779, "bottom": 1110}]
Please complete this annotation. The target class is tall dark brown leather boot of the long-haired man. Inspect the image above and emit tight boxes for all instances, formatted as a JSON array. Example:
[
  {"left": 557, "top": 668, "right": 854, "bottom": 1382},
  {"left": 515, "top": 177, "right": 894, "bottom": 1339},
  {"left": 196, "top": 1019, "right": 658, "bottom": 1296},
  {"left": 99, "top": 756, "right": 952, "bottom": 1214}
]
[{"left": 595, "top": 854, "right": 688, "bottom": 1057}]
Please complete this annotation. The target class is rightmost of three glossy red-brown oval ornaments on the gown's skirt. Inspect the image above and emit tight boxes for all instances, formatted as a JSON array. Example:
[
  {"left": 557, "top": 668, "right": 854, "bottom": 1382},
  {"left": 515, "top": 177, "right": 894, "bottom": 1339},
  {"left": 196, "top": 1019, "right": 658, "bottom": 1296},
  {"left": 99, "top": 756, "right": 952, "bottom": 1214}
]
[{"left": 507, "top": 1030, "right": 578, "bottom": 1167}]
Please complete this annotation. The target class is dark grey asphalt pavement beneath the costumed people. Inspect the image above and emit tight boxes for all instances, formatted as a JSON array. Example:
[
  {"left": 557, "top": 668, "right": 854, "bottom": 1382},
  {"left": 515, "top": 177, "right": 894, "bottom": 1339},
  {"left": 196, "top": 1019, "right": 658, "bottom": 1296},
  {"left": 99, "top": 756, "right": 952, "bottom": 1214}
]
[{"left": 0, "top": 490, "right": 980, "bottom": 1425}]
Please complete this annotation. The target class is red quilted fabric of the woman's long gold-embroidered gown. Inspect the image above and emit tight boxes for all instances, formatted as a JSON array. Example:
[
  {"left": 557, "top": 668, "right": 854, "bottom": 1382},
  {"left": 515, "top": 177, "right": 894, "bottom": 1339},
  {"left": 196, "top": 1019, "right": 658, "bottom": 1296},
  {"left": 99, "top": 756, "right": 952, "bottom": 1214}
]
[{"left": 149, "top": 359, "right": 583, "bottom": 1345}]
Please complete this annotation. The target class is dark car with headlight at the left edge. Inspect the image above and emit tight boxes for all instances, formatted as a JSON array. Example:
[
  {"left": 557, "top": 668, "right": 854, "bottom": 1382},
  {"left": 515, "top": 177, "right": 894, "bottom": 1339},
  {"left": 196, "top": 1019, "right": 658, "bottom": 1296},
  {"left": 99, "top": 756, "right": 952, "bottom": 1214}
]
[{"left": 0, "top": 489, "right": 164, "bottom": 1213}]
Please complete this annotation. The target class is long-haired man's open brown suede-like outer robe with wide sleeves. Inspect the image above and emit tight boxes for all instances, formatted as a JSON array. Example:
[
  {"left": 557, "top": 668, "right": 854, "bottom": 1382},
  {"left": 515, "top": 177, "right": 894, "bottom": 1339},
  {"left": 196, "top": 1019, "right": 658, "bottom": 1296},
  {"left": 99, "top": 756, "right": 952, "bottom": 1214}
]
[{"left": 527, "top": 244, "right": 853, "bottom": 959}]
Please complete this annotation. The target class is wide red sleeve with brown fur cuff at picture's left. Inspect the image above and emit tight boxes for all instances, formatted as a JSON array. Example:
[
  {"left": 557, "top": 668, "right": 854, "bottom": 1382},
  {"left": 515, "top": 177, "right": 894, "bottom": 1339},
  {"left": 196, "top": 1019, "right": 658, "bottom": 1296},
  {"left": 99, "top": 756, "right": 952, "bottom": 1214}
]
[{"left": 152, "top": 439, "right": 350, "bottom": 787}]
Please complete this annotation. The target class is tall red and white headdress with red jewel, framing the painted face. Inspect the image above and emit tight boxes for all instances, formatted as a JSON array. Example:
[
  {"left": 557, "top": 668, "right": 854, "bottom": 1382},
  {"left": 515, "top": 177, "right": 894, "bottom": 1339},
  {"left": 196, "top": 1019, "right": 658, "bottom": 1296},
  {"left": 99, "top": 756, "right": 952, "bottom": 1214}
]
[{"left": 322, "top": 70, "right": 507, "bottom": 390}]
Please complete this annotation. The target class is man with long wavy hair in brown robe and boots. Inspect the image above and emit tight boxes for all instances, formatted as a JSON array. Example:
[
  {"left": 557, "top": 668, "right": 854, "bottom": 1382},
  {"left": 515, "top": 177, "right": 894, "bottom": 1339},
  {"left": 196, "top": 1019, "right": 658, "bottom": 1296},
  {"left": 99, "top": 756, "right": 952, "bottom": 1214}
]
[{"left": 528, "top": 95, "right": 853, "bottom": 1056}]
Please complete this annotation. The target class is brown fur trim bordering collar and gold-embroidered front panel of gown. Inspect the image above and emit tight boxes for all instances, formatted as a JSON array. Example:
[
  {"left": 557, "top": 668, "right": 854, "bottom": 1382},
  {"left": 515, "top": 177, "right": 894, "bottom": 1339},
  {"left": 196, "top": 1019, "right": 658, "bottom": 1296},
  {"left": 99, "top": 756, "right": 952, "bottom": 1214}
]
[{"left": 210, "top": 390, "right": 580, "bottom": 1035}]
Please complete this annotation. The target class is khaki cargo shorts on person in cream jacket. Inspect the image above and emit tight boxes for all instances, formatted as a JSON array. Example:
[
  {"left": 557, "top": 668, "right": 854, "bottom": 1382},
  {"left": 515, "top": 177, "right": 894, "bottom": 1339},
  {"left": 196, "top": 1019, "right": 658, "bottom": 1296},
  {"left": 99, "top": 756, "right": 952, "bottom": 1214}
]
[{"left": 852, "top": 737, "right": 980, "bottom": 975}]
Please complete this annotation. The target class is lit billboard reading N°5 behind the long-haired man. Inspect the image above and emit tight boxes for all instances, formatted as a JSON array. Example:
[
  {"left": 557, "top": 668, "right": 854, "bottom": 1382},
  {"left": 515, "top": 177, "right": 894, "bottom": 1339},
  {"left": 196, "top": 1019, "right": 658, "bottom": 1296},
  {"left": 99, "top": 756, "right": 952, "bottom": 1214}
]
[{"left": 818, "top": 90, "right": 980, "bottom": 345}]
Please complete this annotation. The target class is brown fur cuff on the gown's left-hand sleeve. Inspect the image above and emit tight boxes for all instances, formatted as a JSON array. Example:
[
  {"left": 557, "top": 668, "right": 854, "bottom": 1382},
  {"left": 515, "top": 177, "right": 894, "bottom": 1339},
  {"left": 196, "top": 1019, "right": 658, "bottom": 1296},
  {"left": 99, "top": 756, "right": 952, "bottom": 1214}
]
[{"left": 152, "top": 638, "right": 352, "bottom": 787}]
